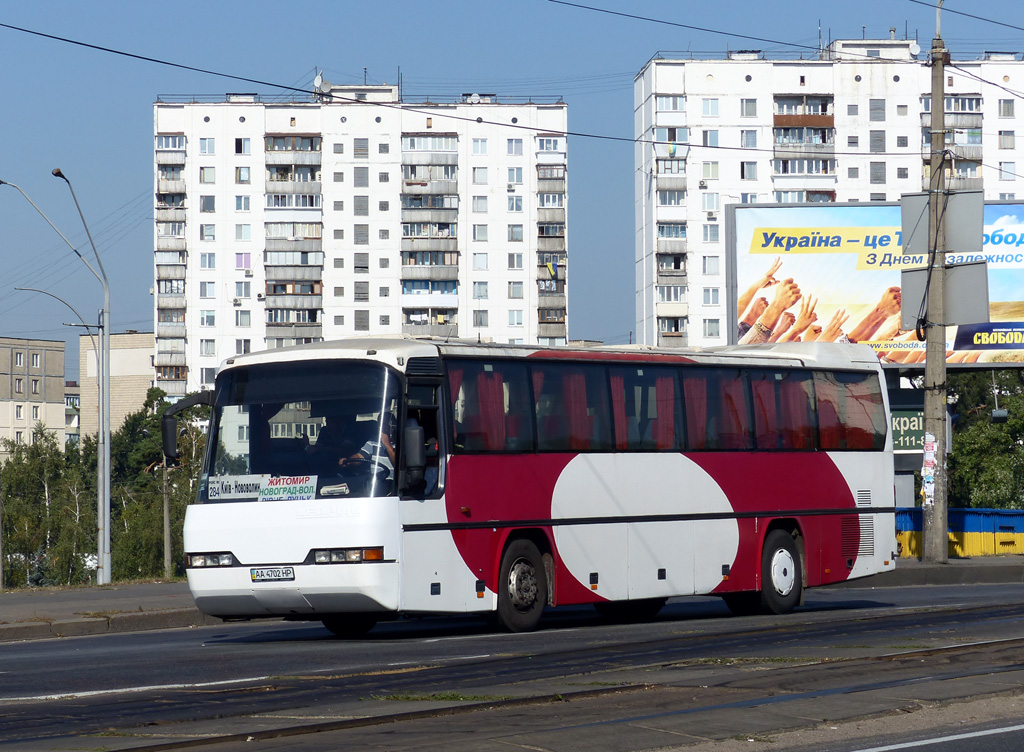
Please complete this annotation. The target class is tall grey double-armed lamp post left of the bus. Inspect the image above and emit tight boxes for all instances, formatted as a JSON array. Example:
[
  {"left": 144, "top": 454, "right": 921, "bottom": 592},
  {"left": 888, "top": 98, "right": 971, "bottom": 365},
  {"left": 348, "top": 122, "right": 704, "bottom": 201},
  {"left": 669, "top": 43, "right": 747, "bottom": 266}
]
[{"left": 0, "top": 178, "right": 111, "bottom": 585}]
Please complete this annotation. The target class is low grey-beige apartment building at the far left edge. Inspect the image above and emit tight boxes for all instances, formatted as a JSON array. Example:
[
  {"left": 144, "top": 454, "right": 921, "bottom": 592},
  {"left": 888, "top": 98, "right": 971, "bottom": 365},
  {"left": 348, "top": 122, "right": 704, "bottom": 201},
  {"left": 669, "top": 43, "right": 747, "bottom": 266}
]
[{"left": 0, "top": 337, "right": 65, "bottom": 459}]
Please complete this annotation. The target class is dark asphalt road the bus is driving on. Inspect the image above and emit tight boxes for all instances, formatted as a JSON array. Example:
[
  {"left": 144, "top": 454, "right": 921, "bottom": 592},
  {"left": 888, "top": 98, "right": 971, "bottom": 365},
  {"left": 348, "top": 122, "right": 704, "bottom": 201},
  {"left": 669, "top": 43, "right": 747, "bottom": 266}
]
[{"left": 0, "top": 585, "right": 1024, "bottom": 752}]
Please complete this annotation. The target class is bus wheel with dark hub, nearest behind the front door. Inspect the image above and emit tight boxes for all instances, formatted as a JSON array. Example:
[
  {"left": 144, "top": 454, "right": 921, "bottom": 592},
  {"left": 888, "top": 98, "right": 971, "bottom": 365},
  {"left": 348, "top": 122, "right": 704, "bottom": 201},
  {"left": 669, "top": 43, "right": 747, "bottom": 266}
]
[{"left": 498, "top": 538, "right": 548, "bottom": 632}]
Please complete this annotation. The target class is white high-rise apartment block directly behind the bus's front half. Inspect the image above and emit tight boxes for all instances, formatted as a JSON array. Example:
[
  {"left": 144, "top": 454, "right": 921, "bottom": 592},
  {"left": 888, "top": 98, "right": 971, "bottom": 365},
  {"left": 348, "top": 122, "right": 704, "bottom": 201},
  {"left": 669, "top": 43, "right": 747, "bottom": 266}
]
[{"left": 154, "top": 82, "right": 568, "bottom": 396}]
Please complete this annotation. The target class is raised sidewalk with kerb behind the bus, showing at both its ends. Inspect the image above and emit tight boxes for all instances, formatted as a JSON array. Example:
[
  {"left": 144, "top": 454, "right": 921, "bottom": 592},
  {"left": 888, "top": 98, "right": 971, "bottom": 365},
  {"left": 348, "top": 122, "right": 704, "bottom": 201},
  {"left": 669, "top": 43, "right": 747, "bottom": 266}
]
[{"left": 0, "top": 555, "right": 1024, "bottom": 641}]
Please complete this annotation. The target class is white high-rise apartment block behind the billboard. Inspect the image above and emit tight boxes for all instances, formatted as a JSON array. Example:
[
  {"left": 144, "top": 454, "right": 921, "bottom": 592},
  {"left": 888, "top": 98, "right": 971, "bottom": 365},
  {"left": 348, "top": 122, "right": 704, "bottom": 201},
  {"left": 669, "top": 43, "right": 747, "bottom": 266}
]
[{"left": 634, "top": 36, "right": 1024, "bottom": 347}]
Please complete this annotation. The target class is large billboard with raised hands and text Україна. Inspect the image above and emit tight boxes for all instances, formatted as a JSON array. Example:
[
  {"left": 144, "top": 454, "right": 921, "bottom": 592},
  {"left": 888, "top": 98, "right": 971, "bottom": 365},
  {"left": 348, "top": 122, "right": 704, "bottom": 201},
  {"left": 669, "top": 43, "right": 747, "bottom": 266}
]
[{"left": 726, "top": 202, "right": 1024, "bottom": 368}]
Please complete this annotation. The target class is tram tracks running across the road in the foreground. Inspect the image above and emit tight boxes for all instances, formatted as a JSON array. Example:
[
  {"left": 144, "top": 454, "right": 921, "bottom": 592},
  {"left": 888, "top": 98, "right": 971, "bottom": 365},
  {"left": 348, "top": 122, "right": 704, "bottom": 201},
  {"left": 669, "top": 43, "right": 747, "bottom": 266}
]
[{"left": 6, "top": 607, "right": 1024, "bottom": 750}]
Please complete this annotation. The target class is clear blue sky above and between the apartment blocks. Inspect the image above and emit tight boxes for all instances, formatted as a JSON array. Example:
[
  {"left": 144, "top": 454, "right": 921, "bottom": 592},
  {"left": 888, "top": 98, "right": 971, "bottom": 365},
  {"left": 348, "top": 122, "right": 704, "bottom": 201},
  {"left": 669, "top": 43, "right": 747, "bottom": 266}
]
[{"left": 0, "top": 0, "right": 1024, "bottom": 378}]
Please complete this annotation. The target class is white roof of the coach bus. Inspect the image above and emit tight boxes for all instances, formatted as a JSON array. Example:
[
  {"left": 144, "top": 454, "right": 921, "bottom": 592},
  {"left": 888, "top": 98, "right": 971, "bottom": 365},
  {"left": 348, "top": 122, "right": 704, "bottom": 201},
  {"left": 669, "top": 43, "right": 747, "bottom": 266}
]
[{"left": 221, "top": 334, "right": 881, "bottom": 371}]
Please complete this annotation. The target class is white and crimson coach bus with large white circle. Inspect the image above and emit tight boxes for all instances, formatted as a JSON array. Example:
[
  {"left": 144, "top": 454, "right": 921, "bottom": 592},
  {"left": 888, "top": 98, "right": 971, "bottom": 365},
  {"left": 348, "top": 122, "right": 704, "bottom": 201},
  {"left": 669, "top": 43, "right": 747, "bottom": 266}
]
[{"left": 163, "top": 335, "right": 896, "bottom": 636}]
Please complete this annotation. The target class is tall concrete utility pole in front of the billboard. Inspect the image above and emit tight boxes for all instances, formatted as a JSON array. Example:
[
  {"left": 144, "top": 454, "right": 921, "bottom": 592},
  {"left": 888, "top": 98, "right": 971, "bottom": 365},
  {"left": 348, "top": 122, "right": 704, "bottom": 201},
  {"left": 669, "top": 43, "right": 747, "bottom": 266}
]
[{"left": 919, "top": 0, "right": 949, "bottom": 563}]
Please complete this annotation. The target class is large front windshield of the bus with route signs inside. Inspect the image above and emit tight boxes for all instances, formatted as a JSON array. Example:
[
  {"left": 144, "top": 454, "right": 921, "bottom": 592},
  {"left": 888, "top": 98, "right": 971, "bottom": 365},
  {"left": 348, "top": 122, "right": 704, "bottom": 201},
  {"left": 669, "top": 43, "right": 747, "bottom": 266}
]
[{"left": 198, "top": 361, "right": 401, "bottom": 502}]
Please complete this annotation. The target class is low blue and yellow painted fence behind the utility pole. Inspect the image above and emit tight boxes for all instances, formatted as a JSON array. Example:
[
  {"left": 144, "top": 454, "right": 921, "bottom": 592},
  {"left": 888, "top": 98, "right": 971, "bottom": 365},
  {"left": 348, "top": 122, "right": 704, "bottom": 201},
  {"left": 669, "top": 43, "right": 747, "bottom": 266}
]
[{"left": 896, "top": 507, "right": 1024, "bottom": 557}]
